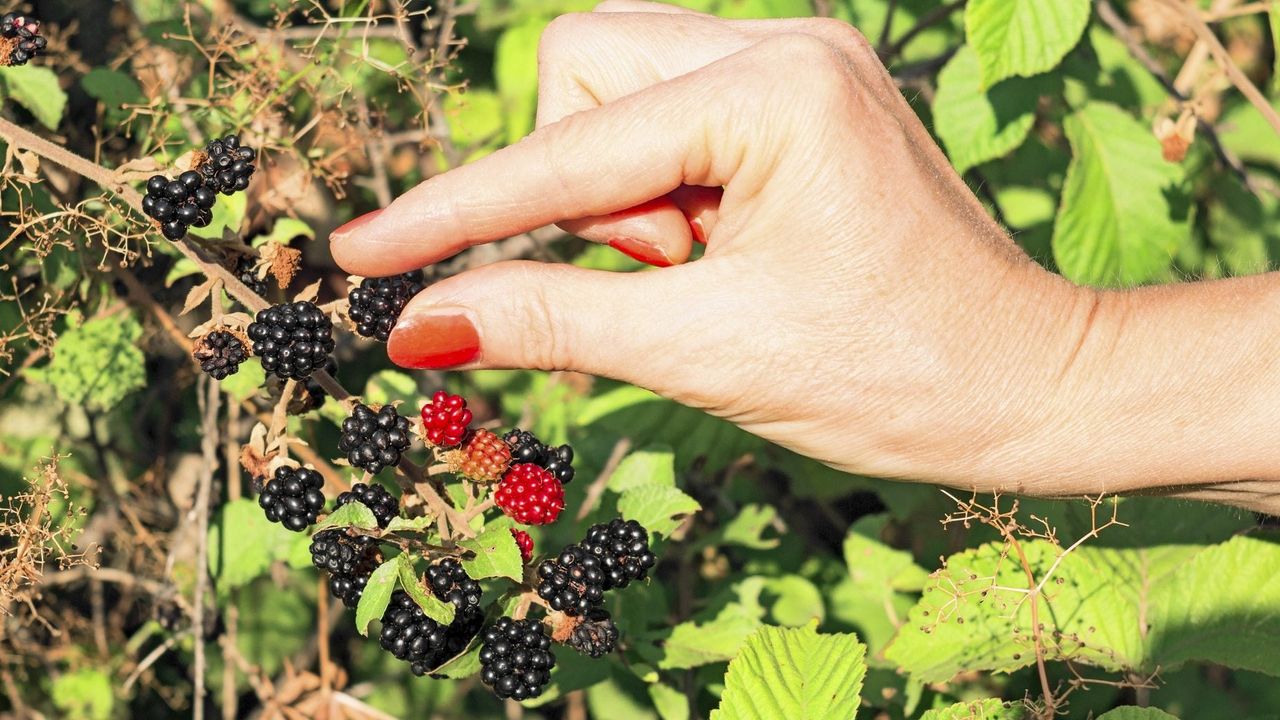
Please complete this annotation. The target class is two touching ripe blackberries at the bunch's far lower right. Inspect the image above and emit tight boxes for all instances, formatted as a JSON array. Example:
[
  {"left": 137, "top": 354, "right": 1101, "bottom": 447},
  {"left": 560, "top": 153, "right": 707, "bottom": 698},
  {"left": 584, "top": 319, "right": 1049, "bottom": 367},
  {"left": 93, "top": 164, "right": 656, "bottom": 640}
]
[{"left": 538, "top": 518, "right": 657, "bottom": 616}]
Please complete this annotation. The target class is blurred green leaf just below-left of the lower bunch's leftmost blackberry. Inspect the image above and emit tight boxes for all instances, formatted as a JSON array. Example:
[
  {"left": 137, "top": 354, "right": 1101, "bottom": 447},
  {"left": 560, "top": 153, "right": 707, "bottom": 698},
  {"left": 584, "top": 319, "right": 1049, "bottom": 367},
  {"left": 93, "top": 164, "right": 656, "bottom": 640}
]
[{"left": 209, "top": 497, "right": 302, "bottom": 593}]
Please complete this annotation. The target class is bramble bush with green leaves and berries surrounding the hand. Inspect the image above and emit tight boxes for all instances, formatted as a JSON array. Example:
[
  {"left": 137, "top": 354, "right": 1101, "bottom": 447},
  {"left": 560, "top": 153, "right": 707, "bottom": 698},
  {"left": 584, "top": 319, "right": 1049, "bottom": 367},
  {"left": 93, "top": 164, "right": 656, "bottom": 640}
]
[{"left": 0, "top": 0, "right": 1280, "bottom": 720}]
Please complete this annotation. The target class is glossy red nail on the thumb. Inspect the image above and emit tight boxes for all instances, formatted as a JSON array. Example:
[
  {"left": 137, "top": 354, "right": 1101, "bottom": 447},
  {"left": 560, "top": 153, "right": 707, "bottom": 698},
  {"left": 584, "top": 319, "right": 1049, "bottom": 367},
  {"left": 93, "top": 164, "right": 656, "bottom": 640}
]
[{"left": 387, "top": 307, "right": 480, "bottom": 369}]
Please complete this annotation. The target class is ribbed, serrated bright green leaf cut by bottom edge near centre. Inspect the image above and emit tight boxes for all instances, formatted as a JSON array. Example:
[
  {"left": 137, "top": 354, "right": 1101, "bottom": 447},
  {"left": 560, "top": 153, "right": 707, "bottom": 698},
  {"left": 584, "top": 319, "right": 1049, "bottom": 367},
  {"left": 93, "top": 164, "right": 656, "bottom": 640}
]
[{"left": 712, "top": 624, "right": 867, "bottom": 720}]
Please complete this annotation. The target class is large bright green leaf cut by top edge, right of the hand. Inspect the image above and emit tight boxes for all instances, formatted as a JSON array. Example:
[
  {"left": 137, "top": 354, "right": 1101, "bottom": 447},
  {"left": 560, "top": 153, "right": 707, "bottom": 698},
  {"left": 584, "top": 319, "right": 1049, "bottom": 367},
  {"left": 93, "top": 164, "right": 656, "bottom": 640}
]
[{"left": 964, "top": 0, "right": 1091, "bottom": 87}]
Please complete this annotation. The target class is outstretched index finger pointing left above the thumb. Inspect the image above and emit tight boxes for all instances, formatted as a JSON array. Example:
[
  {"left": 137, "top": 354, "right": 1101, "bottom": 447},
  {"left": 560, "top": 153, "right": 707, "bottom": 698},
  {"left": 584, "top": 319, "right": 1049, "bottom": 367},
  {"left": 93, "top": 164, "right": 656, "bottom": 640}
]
[{"left": 330, "top": 44, "right": 785, "bottom": 275}]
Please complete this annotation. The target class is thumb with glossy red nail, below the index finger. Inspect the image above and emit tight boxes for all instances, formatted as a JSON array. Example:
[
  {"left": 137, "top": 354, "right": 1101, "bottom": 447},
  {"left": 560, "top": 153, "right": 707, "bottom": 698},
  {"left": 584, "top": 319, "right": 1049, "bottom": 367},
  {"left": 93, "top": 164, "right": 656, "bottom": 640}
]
[{"left": 387, "top": 261, "right": 703, "bottom": 381}]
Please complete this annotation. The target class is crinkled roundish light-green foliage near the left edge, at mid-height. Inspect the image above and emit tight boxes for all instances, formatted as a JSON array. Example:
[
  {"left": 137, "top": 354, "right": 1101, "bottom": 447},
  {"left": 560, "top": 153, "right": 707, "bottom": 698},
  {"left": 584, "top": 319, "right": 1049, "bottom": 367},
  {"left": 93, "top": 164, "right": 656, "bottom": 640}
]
[{"left": 27, "top": 313, "right": 146, "bottom": 410}]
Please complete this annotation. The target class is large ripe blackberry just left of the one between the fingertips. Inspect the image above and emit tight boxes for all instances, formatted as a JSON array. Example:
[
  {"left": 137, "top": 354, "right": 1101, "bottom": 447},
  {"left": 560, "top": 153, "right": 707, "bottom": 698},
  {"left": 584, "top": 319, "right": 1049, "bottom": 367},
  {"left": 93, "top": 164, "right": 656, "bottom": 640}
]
[{"left": 248, "top": 301, "right": 334, "bottom": 380}]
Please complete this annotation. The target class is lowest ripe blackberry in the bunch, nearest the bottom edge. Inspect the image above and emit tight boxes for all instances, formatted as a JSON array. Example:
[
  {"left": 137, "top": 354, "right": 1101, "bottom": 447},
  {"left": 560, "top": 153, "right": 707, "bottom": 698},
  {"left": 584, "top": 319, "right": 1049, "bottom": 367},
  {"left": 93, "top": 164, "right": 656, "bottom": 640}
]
[{"left": 480, "top": 618, "right": 556, "bottom": 700}]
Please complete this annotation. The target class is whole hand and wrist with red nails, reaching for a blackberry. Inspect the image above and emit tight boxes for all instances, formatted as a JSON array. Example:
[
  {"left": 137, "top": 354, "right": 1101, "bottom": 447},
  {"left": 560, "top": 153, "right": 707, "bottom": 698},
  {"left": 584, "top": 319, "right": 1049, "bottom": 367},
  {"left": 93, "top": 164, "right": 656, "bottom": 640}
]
[{"left": 330, "top": 0, "right": 1280, "bottom": 512}]
